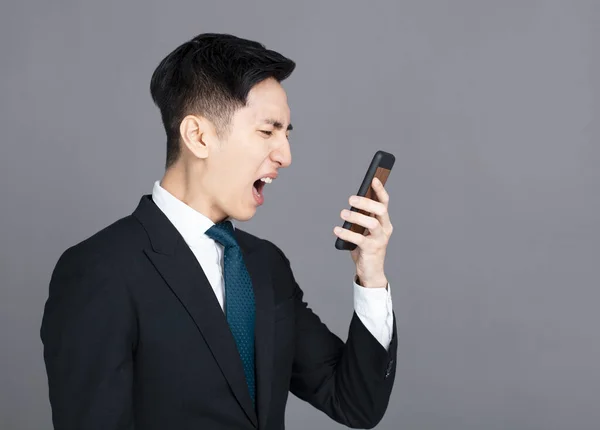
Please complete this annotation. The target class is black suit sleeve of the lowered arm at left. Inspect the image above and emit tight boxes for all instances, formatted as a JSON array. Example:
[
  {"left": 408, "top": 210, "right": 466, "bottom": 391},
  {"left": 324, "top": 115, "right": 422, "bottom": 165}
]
[{"left": 40, "top": 248, "right": 136, "bottom": 430}]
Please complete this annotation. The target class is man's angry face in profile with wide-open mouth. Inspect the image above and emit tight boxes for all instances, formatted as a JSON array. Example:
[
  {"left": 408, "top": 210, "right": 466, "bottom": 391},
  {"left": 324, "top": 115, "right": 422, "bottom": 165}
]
[{"left": 202, "top": 79, "right": 292, "bottom": 221}]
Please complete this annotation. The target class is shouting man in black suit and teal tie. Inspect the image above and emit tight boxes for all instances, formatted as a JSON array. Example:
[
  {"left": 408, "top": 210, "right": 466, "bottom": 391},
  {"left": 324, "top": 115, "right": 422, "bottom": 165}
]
[{"left": 41, "top": 34, "right": 397, "bottom": 430}]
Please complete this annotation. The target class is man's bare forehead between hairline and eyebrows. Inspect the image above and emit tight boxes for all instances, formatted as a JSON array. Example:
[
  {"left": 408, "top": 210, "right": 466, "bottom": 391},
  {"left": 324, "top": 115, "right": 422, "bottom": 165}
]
[{"left": 239, "top": 79, "right": 290, "bottom": 126}]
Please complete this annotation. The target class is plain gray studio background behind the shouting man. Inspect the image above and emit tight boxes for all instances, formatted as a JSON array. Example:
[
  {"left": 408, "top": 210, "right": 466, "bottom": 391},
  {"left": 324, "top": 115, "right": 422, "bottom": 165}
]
[{"left": 0, "top": 0, "right": 600, "bottom": 430}]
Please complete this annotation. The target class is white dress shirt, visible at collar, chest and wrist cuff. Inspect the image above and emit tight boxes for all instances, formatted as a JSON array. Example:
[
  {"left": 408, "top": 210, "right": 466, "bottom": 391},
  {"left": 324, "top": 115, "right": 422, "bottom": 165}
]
[{"left": 152, "top": 181, "right": 393, "bottom": 350}]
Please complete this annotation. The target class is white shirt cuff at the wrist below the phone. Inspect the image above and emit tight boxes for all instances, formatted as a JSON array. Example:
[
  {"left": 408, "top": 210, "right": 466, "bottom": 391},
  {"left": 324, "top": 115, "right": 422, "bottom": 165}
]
[{"left": 354, "top": 281, "right": 394, "bottom": 351}]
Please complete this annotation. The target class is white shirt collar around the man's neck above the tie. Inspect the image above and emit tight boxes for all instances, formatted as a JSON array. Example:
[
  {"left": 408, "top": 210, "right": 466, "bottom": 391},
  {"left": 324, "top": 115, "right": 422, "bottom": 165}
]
[{"left": 152, "top": 181, "right": 235, "bottom": 246}]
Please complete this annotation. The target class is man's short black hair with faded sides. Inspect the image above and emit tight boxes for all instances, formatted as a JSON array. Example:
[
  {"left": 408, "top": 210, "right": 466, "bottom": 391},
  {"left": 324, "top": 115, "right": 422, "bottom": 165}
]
[{"left": 150, "top": 33, "right": 296, "bottom": 168}]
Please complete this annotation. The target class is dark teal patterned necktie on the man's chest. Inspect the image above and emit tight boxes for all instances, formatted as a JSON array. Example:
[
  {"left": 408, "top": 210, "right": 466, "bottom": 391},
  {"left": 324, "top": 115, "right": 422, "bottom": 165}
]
[{"left": 206, "top": 221, "right": 255, "bottom": 403}]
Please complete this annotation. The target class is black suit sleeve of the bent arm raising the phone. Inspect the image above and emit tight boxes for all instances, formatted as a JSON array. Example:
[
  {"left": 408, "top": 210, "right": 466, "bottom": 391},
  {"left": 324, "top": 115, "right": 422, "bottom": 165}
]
[{"left": 279, "top": 245, "right": 398, "bottom": 428}]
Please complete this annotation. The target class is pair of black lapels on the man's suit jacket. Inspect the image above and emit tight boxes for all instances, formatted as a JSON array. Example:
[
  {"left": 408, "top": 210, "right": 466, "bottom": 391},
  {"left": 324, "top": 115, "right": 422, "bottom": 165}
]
[{"left": 133, "top": 195, "right": 274, "bottom": 428}]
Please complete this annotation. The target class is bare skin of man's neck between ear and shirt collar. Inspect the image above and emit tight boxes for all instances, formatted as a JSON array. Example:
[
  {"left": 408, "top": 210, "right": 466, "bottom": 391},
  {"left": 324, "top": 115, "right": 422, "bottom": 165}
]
[{"left": 160, "top": 164, "right": 227, "bottom": 224}]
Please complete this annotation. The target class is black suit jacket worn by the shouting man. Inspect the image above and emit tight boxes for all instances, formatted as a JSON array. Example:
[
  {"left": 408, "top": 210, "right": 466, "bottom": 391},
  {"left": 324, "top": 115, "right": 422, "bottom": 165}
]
[{"left": 41, "top": 195, "right": 397, "bottom": 430}]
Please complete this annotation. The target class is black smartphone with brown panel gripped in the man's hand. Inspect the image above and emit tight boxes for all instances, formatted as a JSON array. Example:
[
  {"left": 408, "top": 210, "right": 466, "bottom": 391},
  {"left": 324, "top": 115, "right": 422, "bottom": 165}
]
[{"left": 335, "top": 151, "right": 396, "bottom": 251}]
